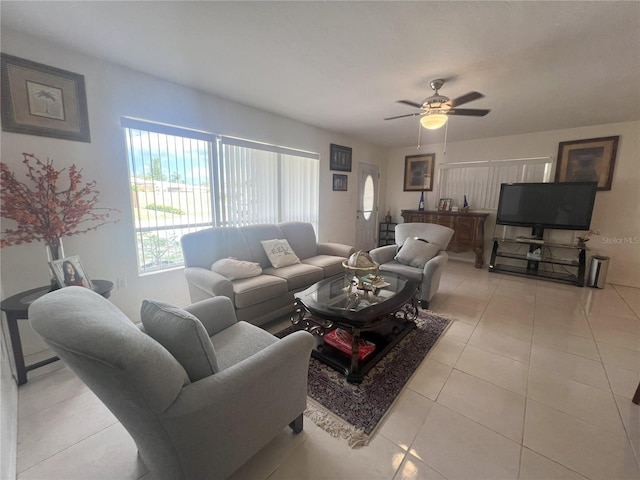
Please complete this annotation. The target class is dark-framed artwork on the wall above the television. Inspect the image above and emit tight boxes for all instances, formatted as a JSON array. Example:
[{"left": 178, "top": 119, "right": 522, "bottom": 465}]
[{"left": 555, "top": 136, "right": 619, "bottom": 190}]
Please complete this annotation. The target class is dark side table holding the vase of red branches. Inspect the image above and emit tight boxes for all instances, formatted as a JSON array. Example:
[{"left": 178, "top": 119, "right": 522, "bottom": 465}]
[{"left": 0, "top": 280, "right": 113, "bottom": 385}]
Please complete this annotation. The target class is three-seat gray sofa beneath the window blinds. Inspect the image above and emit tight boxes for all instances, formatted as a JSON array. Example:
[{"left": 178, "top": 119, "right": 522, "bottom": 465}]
[{"left": 181, "top": 222, "right": 355, "bottom": 325}]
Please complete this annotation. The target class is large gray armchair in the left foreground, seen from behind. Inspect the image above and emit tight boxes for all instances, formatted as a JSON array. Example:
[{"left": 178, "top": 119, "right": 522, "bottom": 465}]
[{"left": 29, "top": 287, "right": 315, "bottom": 480}]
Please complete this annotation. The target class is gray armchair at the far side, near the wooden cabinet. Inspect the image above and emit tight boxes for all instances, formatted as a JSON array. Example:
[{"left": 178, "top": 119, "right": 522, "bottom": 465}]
[{"left": 369, "top": 223, "right": 454, "bottom": 308}]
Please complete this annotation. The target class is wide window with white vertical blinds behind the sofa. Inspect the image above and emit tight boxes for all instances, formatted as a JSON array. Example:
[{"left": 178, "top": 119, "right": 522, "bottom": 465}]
[{"left": 122, "top": 118, "right": 319, "bottom": 273}]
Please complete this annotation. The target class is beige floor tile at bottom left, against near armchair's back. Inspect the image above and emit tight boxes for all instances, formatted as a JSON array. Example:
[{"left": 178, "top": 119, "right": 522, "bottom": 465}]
[{"left": 18, "top": 423, "right": 148, "bottom": 480}]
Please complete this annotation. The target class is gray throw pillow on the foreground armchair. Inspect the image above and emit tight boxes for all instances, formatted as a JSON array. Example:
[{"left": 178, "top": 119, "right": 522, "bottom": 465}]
[{"left": 141, "top": 300, "right": 219, "bottom": 382}]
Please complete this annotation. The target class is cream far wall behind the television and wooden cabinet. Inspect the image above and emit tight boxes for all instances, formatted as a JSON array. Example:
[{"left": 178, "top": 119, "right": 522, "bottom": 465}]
[{"left": 380, "top": 118, "right": 640, "bottom": 287}]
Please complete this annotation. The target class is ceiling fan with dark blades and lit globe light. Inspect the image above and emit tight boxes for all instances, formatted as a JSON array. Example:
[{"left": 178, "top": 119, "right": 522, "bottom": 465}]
[{"left": 385, "top": 78, "right": 491, "bottom": 130}]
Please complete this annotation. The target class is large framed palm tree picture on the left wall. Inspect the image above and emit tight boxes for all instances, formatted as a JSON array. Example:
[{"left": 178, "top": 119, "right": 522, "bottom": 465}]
[{"left": 0, "top": 53, "right": 91, "bottom": 142}]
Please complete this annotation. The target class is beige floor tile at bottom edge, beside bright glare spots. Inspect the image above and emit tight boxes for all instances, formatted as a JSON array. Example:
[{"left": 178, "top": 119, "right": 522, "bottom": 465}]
[{"left": 410, "top": 404, "right": 520, "bottom": 480}]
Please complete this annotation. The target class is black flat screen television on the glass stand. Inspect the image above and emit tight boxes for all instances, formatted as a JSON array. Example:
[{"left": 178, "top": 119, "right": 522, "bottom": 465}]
[{"left": 496, "top": 182, "right": 598, "bottom": 238}]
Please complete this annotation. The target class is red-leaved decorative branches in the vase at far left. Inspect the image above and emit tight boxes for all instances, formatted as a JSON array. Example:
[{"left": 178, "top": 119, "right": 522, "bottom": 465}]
[{"left": 0, "top": 153, "right": 120, "bottom": 251}]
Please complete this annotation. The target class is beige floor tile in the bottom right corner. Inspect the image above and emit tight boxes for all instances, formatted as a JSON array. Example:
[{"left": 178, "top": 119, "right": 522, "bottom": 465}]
[{"left": 524, "top": 400, "right": 640, "bottom": 480}]
